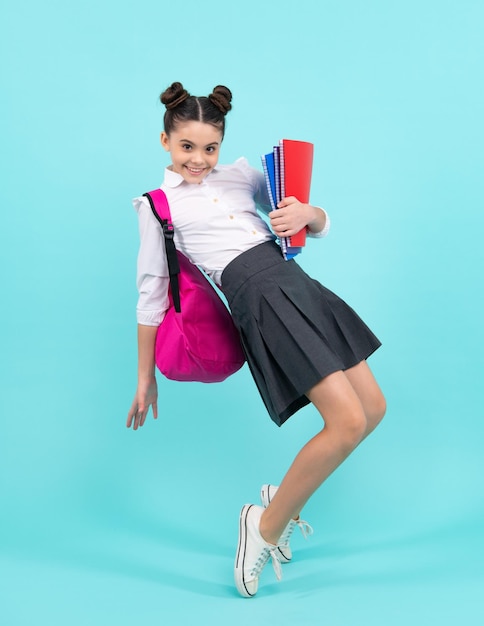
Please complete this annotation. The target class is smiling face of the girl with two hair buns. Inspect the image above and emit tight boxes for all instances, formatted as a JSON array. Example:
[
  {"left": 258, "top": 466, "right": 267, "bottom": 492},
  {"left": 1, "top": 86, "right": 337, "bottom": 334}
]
[{"left": 161, "top": 121, "right": 222, "bottom": 184}]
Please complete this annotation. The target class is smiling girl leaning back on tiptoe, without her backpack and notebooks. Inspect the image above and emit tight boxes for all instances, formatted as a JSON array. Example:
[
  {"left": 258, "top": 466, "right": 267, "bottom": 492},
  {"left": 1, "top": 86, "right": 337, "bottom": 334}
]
[{"left": 127, "top": 83, "right": 385, "bottom": 597}]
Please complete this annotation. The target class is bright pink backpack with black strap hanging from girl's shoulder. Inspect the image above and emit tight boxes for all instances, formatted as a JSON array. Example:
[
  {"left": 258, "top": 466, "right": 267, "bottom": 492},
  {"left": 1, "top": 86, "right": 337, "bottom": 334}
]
[{"left": 144, "top": 189, "right": 245, "bottom": 383}]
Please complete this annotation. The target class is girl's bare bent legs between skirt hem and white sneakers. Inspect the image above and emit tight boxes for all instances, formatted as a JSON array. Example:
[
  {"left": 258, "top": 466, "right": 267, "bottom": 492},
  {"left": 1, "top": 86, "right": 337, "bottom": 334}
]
[{"left": 260, "top": 361, "right": 385, "bottom": 544}]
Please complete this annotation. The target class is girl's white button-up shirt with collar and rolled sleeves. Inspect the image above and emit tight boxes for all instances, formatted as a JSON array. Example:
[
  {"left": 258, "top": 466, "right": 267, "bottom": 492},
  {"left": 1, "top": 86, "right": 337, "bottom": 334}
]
[{"left": 133, "top": 158, "right": 329, "bottom": 326}]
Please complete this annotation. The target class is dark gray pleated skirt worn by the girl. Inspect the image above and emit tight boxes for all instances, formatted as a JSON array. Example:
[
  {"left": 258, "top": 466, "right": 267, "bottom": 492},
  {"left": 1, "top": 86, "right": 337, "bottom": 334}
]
[{"left": 221, "top": 241, "right": 381, "bottom": 426}]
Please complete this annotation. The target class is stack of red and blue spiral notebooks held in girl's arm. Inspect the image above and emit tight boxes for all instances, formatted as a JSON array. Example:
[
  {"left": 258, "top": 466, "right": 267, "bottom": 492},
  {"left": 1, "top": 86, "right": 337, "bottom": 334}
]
[{"left": 261, "top": 139, "right": 314, "bottom": 260}]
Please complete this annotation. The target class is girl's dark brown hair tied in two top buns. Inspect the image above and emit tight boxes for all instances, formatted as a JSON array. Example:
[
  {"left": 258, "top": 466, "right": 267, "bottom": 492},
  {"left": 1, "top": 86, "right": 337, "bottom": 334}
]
[{"left": 160, "top": 83, "right": 232, "bottom": 137}]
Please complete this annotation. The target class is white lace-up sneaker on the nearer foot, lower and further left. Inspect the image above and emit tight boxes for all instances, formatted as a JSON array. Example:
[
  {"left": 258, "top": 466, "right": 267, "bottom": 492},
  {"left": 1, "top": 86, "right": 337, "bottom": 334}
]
[{"left": 234, "top": 504, "right": 282, "bottom": 598}]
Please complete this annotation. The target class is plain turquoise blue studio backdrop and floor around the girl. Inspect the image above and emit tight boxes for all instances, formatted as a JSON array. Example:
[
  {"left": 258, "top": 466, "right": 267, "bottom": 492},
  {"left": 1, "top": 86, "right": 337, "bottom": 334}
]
[{"left": 0, "top": 0, "right": 484, "bottom": 626}]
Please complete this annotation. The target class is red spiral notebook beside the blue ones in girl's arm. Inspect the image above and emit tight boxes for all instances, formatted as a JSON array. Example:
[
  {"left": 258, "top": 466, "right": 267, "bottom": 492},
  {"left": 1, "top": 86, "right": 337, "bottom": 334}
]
[{"left": 279, "top": 139, "right": 314, "bottom": 247}]
